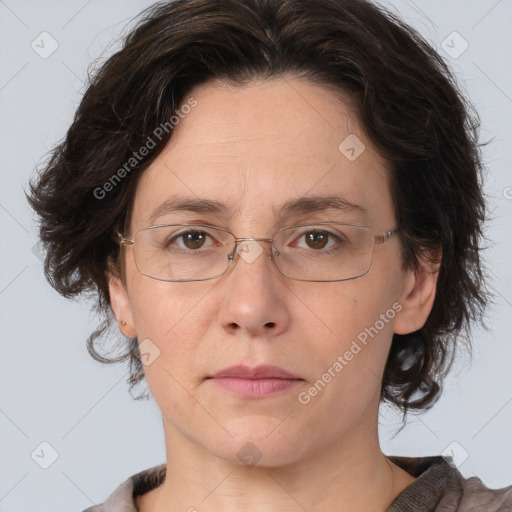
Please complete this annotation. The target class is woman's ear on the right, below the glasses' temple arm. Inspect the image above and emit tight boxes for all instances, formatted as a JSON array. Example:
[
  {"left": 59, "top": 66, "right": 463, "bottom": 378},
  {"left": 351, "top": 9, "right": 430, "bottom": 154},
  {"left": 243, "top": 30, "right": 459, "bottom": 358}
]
[{"left": 393, "top": 250, "right": 441, "bottom": 334}]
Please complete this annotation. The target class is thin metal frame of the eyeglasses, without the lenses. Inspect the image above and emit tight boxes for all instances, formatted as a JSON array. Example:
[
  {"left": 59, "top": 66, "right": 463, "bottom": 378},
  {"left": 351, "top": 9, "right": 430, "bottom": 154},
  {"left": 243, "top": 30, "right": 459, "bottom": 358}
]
[{"left": 116, "top": 222, "right": 400, "bottom": 283}]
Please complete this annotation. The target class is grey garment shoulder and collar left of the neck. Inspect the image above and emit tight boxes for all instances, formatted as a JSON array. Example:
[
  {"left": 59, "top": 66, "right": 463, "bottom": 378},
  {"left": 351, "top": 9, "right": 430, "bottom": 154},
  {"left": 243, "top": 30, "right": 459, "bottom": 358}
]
[{"left": 83, "top": 464, "right": 166, "bottom": 512}]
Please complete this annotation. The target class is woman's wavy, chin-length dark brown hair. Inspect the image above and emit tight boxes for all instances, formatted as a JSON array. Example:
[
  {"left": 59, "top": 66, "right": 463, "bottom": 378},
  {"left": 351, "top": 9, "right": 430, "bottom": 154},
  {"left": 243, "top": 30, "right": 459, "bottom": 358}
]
[{"left": 29, "top": 0, "right": 488, "bottom": 418}]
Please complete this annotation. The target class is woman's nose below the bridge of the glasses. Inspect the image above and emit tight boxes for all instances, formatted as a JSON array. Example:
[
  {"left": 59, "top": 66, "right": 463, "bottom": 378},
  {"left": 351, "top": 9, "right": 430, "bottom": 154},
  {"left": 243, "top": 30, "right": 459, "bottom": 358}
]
[{"left": 219, "top": 238, "right": 290, "bottom": 337}]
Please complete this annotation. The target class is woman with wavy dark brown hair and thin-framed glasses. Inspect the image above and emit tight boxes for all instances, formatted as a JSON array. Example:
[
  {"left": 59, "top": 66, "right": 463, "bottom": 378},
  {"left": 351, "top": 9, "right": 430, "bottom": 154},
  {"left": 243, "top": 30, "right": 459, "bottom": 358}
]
[{"left": 30, "top": 0, "right": 512, "bottom": 512}]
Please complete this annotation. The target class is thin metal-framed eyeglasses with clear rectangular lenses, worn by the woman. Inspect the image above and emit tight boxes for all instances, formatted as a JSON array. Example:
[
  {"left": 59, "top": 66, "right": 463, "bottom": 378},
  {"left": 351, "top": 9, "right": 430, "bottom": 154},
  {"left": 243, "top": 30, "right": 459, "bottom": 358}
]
[{"left": 117, "top": 222, "right": 400, "bottom": 282}]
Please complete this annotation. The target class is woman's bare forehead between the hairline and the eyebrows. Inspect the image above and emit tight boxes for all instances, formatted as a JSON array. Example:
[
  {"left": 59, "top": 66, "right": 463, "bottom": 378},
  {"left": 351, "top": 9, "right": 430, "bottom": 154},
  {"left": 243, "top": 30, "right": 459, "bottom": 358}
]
[{"left": 132, "top": 77, "right": 393, "bottom": 228}]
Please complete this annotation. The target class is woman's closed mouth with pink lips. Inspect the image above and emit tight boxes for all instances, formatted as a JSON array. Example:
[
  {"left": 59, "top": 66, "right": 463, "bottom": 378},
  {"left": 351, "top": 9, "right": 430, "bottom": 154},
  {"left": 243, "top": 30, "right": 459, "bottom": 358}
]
[{"left": 207, "top": 365, "right": 304, "bottom": 398}]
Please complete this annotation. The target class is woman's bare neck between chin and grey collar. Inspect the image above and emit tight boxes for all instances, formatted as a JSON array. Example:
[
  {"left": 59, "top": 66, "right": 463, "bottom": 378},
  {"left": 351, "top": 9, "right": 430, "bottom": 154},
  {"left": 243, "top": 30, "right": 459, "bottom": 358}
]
[{"left": 137, "top": 406, "right": 414, "bottom": 512}]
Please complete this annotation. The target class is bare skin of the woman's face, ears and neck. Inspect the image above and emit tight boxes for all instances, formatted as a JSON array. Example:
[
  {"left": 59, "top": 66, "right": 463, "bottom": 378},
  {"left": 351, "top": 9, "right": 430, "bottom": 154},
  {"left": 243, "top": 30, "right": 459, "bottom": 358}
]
[{"left": 110, "top": 76, "right": 437, "bottom": 512}]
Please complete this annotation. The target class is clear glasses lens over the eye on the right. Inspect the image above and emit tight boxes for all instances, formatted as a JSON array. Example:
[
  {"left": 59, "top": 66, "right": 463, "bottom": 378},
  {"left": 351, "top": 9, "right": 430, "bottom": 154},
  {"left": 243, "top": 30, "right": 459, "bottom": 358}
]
[{"left": 274, "top": 223, "right": 374, "bottom": 281}]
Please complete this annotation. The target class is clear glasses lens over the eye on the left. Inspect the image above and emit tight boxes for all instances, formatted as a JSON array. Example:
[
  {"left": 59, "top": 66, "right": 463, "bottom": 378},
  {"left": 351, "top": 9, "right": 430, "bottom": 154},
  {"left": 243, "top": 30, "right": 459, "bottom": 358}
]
[{"left": 134, "top": 224, "right": 235, "bottom": 281}]
